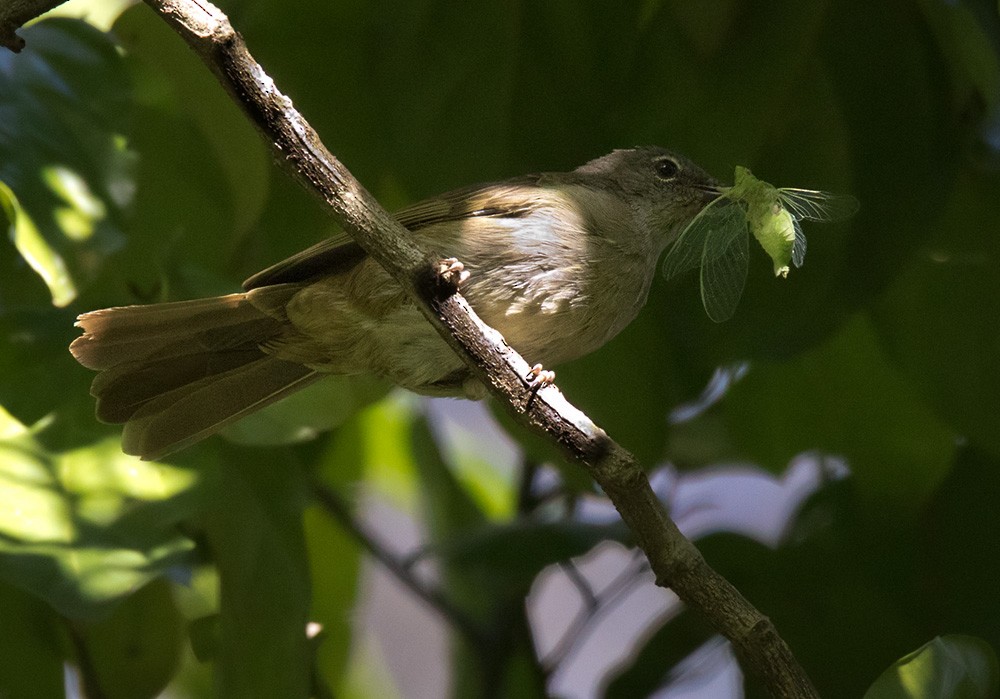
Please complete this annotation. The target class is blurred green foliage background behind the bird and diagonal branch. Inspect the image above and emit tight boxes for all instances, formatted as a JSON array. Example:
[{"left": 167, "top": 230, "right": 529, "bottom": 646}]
[{"left": 0, "top": 0, "right": 1000, "bottom": 697}]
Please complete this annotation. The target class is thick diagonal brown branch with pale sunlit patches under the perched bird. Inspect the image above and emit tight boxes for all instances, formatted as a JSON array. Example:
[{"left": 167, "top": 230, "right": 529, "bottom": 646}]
[{"left": 0, "top": 0, "right": 817, "bottom": 697}]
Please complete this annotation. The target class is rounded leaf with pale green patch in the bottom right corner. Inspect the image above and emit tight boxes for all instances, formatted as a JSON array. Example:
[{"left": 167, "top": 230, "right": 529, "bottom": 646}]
[{"left": 865, "top": 634, "right": 1000, "bottom": 699}]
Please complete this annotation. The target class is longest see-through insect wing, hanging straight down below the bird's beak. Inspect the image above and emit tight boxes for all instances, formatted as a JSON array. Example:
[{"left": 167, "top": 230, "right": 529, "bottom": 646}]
[{"left": 701, "top": 203, "right": 750, "bottom": 323}]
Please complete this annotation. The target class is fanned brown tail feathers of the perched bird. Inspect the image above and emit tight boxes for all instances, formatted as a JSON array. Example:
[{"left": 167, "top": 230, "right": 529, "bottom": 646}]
[{"left": 70, "top": 285, "right": 321, "bottom": 459}]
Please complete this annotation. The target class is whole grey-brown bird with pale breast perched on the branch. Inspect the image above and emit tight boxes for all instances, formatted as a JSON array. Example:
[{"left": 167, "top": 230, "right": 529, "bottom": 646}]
[{"left": 70, "top": 146, "right": 719, "bottom": 460}]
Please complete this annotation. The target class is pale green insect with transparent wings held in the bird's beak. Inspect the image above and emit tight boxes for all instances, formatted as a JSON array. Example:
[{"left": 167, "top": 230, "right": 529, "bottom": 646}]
[{"left": 663, "top": 166, "right": 858, "bottom": 323}]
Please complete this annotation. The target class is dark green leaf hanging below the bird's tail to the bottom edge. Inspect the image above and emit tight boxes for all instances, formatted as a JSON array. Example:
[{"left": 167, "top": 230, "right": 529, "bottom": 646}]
[{"left": 206, "top": 447, "right": 311, "bottom": 697}]
